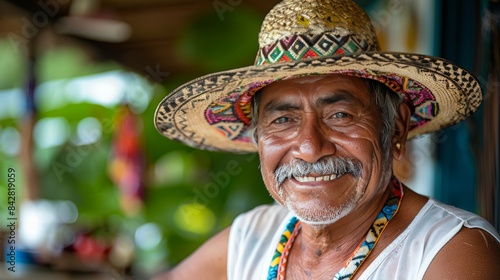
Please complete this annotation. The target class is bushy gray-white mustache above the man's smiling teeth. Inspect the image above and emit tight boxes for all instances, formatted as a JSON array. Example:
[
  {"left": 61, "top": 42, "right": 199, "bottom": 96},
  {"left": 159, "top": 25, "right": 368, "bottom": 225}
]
[{"left": 274, "top": 157, "right": 363, "bottom": 186}]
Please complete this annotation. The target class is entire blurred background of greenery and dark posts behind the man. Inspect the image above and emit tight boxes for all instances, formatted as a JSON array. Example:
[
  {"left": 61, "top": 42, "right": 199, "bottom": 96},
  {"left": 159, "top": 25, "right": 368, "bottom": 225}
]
[{"left": 0, "top": 0, "right": 500, "bottom": 280}]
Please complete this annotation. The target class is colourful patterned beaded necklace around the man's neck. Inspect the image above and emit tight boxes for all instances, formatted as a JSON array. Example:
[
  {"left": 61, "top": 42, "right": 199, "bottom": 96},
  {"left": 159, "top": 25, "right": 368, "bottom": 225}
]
[{"left": 267, "top": 177, "right": 403, "bottom": 280}]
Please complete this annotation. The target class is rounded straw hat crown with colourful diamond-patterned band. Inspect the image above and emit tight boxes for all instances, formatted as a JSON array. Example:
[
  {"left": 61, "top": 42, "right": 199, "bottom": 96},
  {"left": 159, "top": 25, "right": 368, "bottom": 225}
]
[{"left": 256, "top": 0, "right": 380, "bottom": 65}]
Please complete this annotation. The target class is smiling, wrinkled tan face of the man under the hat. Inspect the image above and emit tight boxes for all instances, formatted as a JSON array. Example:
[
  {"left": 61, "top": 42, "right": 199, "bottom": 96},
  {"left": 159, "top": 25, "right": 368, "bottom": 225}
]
[{"left": 257, "top": 75, "right": 392, "bottom": 224}]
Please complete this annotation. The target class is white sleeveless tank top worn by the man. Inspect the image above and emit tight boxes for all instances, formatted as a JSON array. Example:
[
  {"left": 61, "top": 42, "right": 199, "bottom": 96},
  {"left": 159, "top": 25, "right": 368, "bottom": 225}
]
[{"left": 227, "top": 199, "right": 500, "bottom": 280}]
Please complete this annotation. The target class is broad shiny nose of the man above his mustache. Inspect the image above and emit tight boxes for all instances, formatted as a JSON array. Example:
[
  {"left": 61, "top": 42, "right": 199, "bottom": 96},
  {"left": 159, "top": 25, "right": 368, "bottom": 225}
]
[{"left": 292, "top": 118, "right": 336, "bottom": 163}]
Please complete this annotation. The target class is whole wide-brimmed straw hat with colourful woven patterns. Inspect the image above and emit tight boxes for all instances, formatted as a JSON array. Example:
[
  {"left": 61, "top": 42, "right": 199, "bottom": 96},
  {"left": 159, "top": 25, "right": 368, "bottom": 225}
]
[{"left": 155, "top": 0, "right": 482, "bottom": 152}]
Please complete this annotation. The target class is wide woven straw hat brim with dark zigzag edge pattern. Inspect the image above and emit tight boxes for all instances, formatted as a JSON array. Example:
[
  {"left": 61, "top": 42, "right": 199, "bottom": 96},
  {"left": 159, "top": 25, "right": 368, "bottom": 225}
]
[{"left": 154, "top": 52, "right": 482, "bottom": 153}]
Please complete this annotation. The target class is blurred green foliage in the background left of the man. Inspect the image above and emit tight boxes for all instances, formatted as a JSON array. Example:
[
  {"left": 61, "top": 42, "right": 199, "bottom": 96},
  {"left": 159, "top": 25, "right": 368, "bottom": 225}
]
[{"left": 0, "top": 2, "right": 272, "bottom": 271}]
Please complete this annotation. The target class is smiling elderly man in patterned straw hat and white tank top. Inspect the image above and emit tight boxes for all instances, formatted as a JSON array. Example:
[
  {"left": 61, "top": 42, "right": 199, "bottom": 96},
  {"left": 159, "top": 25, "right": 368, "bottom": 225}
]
[{"left": 155, "top": 0, "right": 500, "bottom": 279}]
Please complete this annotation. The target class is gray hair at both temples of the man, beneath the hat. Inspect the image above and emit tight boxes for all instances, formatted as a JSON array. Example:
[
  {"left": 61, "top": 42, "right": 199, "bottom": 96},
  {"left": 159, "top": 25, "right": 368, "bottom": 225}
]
[{"left": 250, "top": 79, "right": 403, "bottom": 162}]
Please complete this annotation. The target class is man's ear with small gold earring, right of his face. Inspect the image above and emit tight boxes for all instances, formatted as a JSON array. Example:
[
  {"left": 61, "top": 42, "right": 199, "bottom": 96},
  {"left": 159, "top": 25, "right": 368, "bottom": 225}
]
[{"left": 392, "top": 102, "right": 411, "bottom": 160}]
